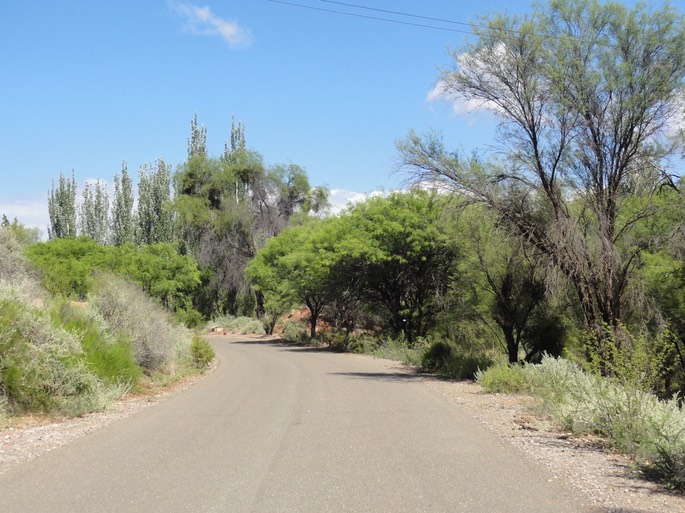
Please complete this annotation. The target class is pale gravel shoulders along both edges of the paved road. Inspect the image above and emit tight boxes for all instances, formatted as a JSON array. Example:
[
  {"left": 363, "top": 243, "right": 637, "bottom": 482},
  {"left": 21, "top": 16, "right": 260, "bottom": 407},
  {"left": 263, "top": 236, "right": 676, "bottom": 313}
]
[{"left": 0, "top": 334, "right": 685, "bottom": 513}]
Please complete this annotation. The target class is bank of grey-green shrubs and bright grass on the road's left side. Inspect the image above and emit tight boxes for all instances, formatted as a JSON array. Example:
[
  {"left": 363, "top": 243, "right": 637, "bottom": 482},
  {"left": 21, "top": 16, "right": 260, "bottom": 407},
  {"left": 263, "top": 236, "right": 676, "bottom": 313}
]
[{"left": 0, "top": 225, "right": 213, "bottom": 421}]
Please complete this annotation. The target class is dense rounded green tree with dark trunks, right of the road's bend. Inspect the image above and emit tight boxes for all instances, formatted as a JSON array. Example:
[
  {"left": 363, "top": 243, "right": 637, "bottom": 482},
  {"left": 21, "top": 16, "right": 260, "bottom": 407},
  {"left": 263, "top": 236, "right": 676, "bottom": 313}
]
[{"left": 347, "top": 190, "right": 457, "bottom": 344}]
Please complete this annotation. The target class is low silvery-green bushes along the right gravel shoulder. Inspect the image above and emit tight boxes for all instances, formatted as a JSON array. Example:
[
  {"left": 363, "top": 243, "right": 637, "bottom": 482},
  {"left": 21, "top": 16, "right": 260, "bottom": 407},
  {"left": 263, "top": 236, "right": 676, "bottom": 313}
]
[{"left": 477, "top": 357, "right": 685, "bottom": 492}]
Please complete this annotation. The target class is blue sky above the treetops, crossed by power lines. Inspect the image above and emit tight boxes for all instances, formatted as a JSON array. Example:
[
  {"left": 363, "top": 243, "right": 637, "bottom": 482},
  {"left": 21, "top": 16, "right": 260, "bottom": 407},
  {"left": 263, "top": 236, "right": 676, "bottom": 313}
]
[{"left": 0, "top": 0, "right": 677, "bottom": 234}]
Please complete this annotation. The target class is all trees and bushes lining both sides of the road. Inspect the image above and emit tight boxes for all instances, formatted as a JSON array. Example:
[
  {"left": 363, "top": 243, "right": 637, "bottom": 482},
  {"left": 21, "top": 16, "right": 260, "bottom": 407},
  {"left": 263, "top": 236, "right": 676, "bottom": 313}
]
[{"left": 0, "top": 0, "right": 685, "bottom": 490}]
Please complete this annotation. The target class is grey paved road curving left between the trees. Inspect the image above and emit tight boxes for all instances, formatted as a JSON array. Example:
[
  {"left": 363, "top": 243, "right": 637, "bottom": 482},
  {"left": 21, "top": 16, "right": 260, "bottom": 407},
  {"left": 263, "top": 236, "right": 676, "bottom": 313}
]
[{"left": 0, "top": 339, "right": 598, "bottom": 513}]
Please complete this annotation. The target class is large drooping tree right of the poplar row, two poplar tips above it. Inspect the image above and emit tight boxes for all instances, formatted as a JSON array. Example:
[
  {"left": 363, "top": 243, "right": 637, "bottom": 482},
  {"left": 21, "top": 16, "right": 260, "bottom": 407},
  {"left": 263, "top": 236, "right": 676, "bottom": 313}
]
[{"left": 174, "top": 115, "right": 326, "bottom": 315}]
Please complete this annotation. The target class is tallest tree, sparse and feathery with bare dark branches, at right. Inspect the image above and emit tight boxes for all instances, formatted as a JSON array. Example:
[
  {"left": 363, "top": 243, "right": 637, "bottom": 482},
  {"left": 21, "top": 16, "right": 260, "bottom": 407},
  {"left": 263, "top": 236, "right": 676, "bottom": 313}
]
[{"left": 399, "top": 0, "right": 685, "bottom": 372}]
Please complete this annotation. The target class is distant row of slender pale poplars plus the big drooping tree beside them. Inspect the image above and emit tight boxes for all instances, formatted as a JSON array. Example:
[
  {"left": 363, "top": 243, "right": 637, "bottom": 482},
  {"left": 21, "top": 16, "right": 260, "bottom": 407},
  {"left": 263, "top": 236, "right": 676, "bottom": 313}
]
[{"left": 48, "top": 116, "right": 328, "bottom": 318}]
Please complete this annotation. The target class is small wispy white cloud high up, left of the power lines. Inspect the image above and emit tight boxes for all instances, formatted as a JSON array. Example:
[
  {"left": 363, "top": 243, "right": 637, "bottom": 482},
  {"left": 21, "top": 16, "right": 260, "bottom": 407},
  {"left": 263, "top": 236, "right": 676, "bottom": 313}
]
[{"left": 169, "top": 1, "right": 252, "bottom": 48}]
